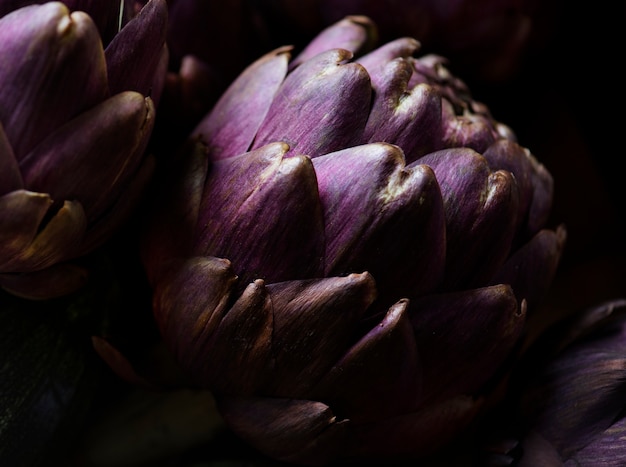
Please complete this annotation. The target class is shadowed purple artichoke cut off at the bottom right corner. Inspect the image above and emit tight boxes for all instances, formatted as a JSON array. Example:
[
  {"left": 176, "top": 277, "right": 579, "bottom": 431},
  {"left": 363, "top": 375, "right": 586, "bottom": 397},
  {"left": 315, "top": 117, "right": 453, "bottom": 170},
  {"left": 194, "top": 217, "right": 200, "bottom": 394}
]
[{"left": 488, "top": 299, "right": 626, "bottom": 467}]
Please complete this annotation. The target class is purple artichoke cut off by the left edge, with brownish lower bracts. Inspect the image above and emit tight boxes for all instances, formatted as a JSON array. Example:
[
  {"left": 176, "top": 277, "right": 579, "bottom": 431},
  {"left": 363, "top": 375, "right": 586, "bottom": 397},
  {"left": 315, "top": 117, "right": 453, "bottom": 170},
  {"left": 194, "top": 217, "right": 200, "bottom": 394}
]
[{"left": 0, "top": 0, "right": 168, "bottom": 298}]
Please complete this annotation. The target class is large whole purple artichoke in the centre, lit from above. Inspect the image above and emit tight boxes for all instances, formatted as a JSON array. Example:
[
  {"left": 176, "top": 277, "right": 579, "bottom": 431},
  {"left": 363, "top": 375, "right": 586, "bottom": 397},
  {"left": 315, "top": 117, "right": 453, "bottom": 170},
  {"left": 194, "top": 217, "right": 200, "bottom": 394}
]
[{"left": 142, "top": 16, "right": 566, "bottom": 465}]
